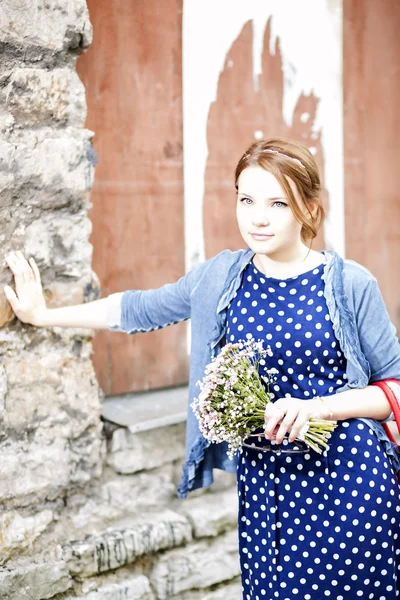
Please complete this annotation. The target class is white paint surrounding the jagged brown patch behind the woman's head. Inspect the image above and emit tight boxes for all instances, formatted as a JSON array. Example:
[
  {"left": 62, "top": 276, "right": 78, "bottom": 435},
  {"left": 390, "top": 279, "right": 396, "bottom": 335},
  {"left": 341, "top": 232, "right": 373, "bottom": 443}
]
[{"left": 183, "top": 0, "right": 345, "bottom": 270}]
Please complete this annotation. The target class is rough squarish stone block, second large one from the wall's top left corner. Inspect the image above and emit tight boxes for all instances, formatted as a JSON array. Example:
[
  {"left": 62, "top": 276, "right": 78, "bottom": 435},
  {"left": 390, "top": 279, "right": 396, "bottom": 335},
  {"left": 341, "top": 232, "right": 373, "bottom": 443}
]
[{"left": 6, "top": 68, "right": 86, "bottom": 127}]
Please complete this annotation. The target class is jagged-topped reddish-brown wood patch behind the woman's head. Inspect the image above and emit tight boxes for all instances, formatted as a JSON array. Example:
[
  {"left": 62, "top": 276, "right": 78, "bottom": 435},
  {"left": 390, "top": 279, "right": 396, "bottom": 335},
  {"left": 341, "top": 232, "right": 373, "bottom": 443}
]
[{"left": 204, "top": 22, "right": 328, "bottom": 257}]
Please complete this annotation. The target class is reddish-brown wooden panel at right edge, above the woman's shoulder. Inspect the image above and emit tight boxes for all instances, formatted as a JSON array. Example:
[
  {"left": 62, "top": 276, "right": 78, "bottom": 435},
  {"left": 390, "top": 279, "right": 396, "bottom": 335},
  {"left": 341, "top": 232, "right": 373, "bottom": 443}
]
[{"left": 344, "top": 0, "right": 400, "bottom": 329}]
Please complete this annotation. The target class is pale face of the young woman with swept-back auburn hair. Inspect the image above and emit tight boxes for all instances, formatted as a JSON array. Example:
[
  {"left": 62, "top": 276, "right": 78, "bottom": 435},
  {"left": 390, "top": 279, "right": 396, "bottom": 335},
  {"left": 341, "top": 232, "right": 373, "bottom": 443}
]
[{"left": 236, "top": 166, "right": 302, "bottom": 257}]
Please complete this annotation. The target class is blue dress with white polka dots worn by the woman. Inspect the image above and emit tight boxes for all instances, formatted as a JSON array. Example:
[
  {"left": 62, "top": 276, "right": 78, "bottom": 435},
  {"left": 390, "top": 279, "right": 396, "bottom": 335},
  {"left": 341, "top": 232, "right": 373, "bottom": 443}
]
[{"left": 227, "top": 263, "right": 400, "bottom": 600}]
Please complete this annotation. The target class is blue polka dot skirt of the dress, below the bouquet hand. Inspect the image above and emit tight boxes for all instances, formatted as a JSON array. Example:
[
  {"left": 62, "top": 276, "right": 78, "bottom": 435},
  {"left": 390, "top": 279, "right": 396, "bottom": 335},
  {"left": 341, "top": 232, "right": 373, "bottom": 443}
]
[{"left": 237, "top": 419, "right": 400, "bottom": 600}]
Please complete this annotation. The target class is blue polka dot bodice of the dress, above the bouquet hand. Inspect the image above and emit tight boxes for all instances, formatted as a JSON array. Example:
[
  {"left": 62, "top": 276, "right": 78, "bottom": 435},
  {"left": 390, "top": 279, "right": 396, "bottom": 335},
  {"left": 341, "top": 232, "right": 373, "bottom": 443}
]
[{"left": 226, "top": 263, "right": 347, "bottom": 398}]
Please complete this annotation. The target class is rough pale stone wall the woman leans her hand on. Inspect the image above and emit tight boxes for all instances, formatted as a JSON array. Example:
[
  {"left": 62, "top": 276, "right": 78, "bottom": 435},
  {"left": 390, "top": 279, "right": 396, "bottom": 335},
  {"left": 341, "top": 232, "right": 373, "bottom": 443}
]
[{"left": 0, "top": 0, "right": 241, "bottom": 600}]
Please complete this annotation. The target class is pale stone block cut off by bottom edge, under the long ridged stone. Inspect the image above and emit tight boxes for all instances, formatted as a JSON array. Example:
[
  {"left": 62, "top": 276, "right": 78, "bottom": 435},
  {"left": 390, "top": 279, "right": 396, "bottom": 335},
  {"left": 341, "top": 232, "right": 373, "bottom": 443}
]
[{"left": 65, "top": 575, "right": 155, "bottom": 600}]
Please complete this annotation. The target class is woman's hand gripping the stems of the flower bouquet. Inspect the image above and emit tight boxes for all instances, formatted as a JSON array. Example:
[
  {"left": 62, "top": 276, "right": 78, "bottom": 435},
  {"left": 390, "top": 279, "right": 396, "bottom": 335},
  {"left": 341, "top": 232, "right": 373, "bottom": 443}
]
[{"left": 264, "top": 397, "right": 329, "bottom": 444}]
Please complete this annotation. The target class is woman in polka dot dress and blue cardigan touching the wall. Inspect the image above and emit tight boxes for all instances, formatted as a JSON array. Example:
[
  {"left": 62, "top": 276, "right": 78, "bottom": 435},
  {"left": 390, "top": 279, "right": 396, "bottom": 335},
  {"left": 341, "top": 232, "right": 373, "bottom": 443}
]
[{"left": 5, "top": 139, "right": 400, "bottom": 600}]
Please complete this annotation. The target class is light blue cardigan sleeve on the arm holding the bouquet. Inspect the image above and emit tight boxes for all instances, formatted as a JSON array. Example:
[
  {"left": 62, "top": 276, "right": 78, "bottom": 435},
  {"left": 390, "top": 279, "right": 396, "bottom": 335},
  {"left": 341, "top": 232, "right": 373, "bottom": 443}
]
[{"left": 356, "top": 277, "right": 400, "bottom": 383}]
